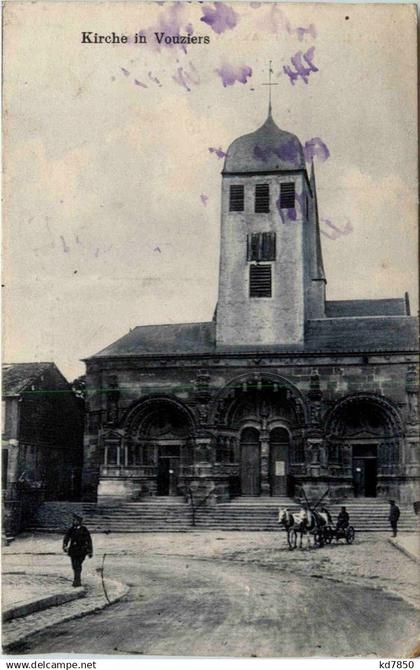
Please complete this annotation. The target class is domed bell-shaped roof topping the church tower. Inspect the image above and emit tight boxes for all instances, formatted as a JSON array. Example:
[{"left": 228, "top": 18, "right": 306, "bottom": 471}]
[{"left": 223, "top": 114, "right": 306, "bottom": 174}]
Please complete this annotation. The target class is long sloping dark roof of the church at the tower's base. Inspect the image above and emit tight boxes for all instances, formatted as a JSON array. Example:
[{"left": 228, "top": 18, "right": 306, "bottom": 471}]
[{"left": 90, "top": 316, "right": 418, "bottom": 360}]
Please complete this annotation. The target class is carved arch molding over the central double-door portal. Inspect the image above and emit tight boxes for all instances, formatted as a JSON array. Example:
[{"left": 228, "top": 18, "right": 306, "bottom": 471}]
[{"left": 209, "top": 372, "right": 308, "bottom": 425}]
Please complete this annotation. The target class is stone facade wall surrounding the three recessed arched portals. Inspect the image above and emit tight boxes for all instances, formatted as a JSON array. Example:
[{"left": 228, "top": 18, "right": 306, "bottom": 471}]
[{"left": 84, "top": 353, "right": 420, "bottom": 502}]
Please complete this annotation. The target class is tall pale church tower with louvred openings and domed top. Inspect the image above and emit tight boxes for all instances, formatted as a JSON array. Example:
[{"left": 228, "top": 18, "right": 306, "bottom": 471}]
[{"left": 216, "top": 106, "right": 326, "bottom": 347}]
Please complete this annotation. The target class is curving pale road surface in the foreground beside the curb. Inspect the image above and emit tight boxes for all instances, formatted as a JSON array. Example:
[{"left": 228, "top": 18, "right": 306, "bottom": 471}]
[{"left": 21, "top": 550, "right": 417, "bottom": 658}]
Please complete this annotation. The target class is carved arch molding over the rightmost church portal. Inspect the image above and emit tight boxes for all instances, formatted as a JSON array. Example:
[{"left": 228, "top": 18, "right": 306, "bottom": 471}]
[{"left": 325, "top": 392, "right": 403, "bottom": 440}]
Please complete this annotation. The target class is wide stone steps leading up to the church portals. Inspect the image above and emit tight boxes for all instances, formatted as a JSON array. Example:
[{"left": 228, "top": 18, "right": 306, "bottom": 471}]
[{"left": 27, "top": 497, "right": 418, "bottom": 533}]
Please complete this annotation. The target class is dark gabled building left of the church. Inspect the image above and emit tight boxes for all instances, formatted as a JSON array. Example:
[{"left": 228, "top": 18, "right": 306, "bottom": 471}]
[{"left": 2, "top": 363, "right": 83, "bottom": 516}]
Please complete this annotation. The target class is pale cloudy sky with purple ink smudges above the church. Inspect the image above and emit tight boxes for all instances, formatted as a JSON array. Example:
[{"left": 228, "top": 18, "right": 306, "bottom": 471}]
[{"left": 3, "top": 2, "right": 418, "bottom": 380}]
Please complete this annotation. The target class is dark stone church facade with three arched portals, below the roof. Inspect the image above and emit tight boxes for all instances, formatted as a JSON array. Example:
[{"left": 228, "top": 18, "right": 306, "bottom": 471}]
[{"left": 83, "top": 354, "right": 420, "bottom": 502}]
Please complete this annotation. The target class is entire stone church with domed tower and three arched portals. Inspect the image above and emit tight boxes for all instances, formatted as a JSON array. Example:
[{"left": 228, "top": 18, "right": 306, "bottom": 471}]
[{"left": 82, "top": 109, "right": 420, "bottom": 505}]
